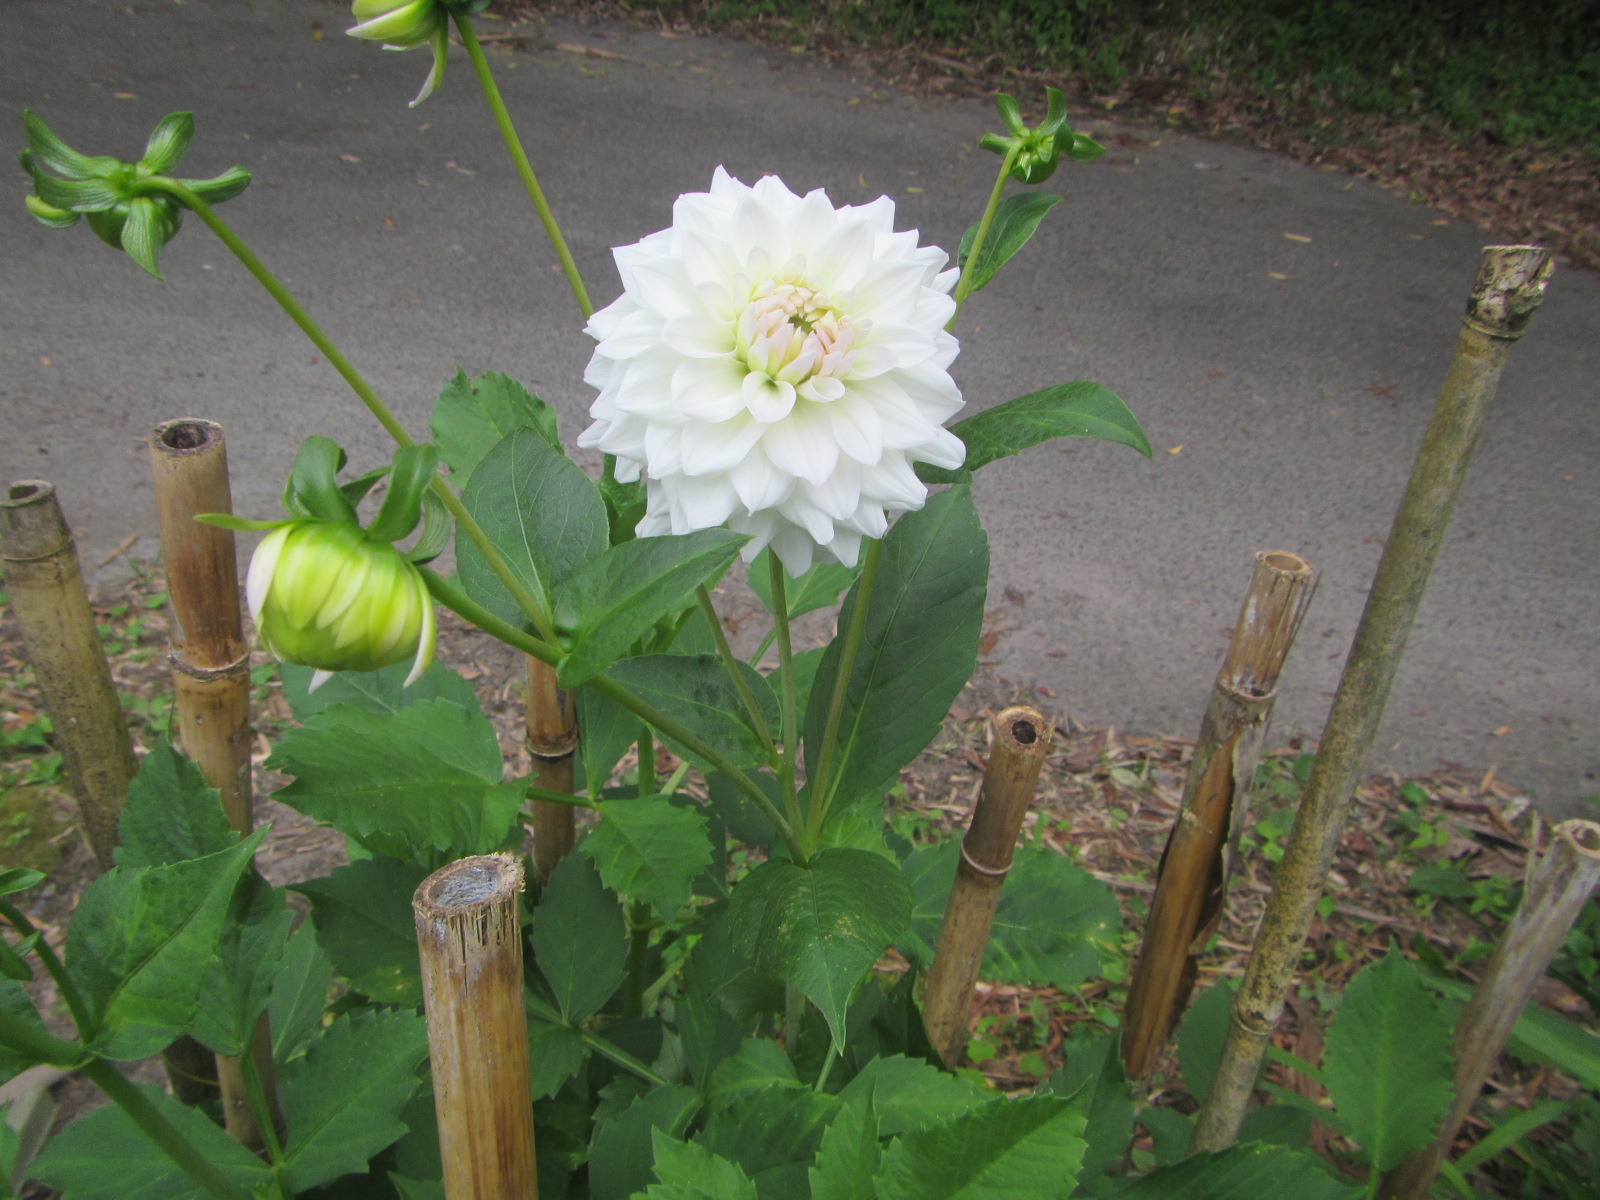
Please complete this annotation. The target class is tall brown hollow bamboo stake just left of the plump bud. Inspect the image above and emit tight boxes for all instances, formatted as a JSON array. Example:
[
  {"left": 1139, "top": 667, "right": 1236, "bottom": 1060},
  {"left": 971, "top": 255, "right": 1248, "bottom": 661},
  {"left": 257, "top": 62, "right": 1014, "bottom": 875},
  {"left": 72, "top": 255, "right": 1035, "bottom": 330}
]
[{"left": 150, "top": 418, "right": 283, "bottom": 1150}]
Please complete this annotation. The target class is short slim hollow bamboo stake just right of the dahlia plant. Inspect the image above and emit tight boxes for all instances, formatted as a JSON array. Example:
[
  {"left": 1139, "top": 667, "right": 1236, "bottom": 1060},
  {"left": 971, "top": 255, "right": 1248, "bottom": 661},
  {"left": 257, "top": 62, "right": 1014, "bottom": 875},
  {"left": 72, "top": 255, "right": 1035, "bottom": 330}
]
[{"left": 922, "top": 706, "right": 1051, "bottom": 1066}]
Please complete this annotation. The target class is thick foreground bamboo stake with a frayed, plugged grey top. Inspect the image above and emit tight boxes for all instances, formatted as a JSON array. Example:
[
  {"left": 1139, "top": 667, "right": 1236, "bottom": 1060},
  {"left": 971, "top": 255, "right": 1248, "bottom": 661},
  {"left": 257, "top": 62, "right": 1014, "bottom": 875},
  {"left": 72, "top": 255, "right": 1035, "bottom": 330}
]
[{"left": 411, "top": 854, "right": 539, "bottom": 1200}]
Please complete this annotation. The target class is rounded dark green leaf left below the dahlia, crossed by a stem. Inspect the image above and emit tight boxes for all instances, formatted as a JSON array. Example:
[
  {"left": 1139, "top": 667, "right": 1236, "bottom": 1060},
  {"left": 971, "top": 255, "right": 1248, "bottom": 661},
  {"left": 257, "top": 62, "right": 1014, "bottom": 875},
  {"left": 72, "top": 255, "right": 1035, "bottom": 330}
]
[{"left": 456, "top": 429, "right": 610, "bottom": 627}]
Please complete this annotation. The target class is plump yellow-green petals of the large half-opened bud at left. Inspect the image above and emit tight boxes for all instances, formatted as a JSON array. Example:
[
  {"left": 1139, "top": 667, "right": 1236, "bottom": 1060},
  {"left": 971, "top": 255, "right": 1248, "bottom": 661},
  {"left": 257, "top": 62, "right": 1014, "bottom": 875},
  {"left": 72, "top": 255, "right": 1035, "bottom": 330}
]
[{"left": 245, "top": 520, "right": 437, "bottom": 688}]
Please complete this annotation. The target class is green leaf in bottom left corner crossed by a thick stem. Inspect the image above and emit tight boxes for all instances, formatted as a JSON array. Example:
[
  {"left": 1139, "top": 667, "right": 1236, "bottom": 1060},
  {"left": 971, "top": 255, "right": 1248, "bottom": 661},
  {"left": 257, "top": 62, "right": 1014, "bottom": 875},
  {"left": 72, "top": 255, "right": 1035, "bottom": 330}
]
[{"left": 29, "top": 1083, "right": 272, "bottom": 1200}]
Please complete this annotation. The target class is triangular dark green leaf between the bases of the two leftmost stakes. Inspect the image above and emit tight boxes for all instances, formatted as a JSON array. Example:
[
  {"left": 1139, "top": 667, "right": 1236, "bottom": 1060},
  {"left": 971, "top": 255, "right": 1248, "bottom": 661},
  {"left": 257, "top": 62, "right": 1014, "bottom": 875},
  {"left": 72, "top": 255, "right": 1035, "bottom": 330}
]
[{"left": 115, "top": 738, "right": 238, "bottom": 867}]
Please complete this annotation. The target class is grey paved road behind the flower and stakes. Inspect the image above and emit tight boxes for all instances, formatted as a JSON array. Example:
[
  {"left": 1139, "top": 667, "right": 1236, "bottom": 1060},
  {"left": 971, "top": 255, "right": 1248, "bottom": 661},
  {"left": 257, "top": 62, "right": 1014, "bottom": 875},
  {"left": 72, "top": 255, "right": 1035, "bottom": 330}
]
[{"left": 0, "top": 0, "right": 1600, "bottom": 810}]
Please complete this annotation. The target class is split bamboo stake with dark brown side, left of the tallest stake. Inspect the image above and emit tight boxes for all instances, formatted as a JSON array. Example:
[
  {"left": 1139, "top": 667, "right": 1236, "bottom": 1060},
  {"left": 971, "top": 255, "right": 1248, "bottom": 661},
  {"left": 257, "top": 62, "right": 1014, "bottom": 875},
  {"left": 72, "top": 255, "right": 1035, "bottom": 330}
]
[{"left": 1122, "top": 550, "right": 1315, "bottom": 1078}]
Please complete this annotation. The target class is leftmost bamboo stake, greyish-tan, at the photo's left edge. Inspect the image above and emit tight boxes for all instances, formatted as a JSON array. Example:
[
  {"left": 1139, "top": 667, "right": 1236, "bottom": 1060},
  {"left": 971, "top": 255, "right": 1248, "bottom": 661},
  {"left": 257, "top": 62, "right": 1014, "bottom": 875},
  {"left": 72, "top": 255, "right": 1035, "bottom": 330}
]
[{"left": 0, "top": 480, "right": 136, "bottom": 870}]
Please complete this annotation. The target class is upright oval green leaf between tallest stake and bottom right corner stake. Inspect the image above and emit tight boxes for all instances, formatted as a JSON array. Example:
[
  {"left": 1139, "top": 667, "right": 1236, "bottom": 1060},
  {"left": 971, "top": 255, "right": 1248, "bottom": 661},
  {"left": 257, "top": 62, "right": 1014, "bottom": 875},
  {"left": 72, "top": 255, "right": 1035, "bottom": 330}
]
[{"left": 1322, "top": 950, "right": 1454, "bottom": 1171}]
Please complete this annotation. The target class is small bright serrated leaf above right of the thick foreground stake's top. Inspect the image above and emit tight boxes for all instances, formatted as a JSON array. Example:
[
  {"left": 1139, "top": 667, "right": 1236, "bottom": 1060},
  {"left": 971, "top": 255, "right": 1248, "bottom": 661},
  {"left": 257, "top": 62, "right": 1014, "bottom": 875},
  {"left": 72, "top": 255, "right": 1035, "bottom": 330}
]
[{"left": 582, "top": 800, "right": 712, "bottom": 923}]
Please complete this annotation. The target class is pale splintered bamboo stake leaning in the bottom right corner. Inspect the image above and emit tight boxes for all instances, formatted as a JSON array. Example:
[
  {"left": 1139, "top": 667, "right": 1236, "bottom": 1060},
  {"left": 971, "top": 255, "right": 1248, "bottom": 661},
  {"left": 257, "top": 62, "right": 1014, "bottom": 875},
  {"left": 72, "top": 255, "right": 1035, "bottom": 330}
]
[{"left": 1378, "top": 821, "right": 1600, "bottom": 1200}]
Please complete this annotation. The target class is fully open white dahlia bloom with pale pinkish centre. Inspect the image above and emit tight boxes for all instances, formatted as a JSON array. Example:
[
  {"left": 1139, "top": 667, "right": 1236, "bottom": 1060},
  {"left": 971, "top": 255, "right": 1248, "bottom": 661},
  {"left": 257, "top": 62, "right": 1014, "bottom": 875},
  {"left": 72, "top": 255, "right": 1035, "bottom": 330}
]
[{"left": 578, "top": 166, "right": 966, "bottom": 576}]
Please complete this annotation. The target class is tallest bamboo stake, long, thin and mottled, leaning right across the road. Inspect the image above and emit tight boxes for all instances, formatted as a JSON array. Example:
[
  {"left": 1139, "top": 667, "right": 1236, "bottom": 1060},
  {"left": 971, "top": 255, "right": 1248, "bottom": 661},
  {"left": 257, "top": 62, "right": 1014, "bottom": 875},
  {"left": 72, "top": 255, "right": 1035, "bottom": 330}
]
[{"left": 1189, "top": 246, "right": 1550, "bottom": 1154}]
